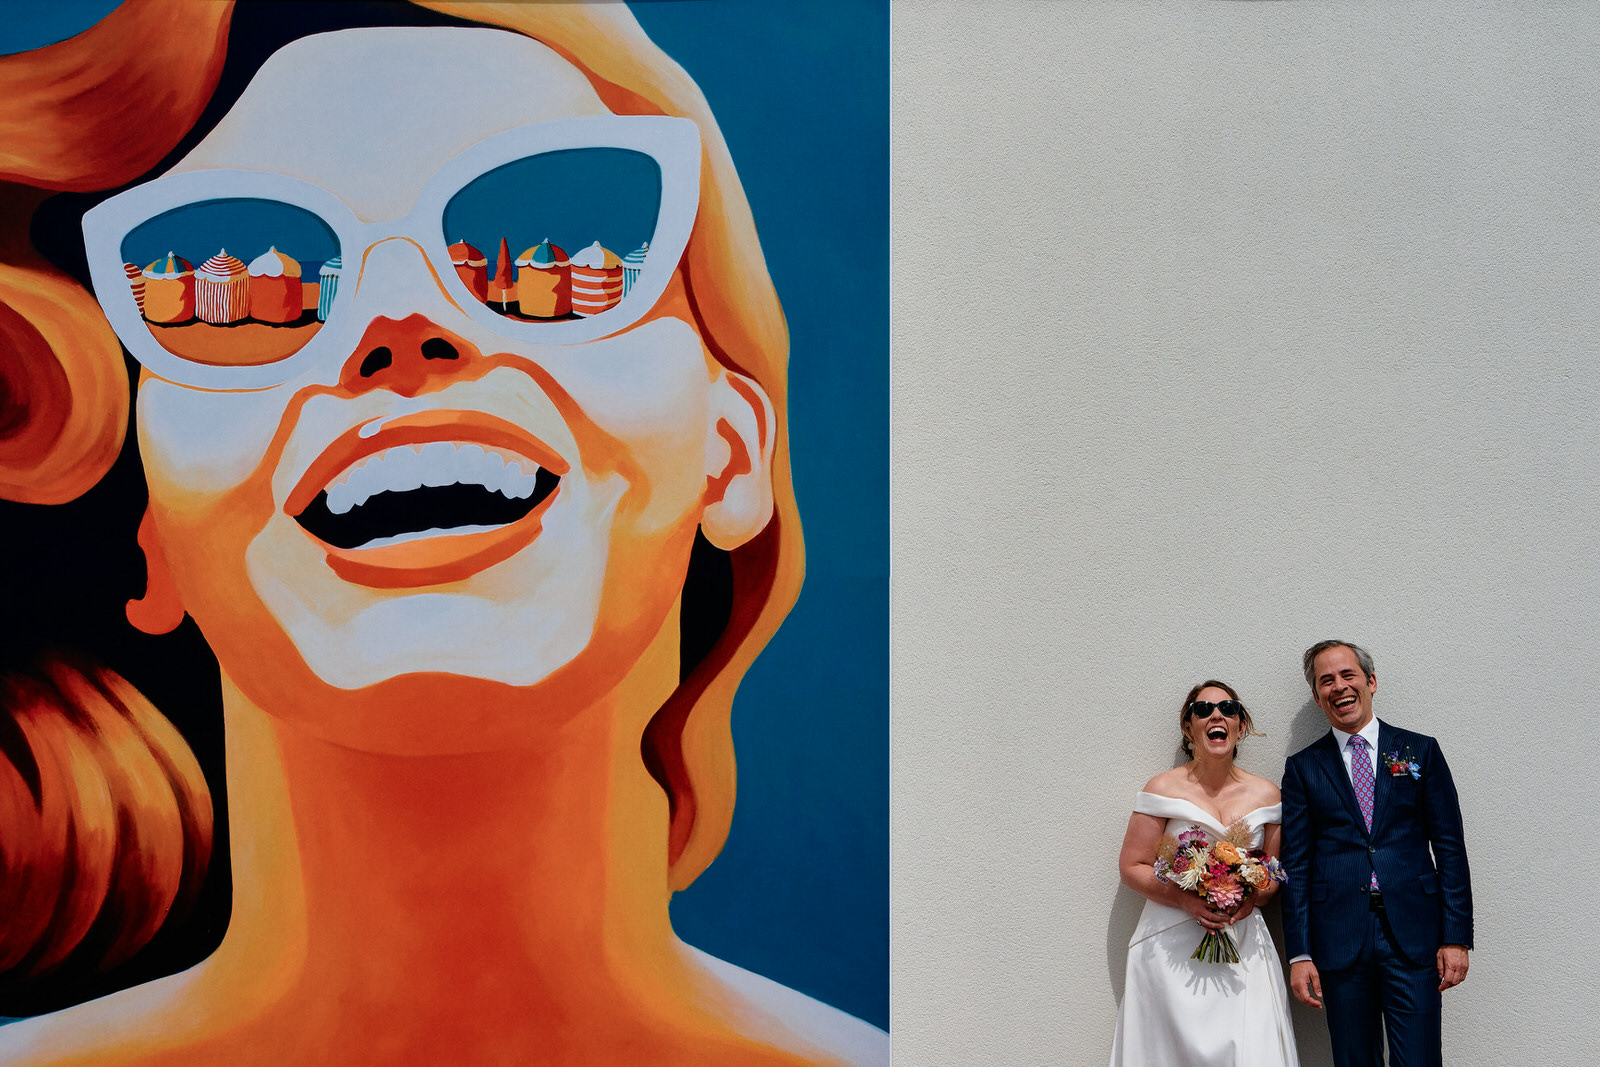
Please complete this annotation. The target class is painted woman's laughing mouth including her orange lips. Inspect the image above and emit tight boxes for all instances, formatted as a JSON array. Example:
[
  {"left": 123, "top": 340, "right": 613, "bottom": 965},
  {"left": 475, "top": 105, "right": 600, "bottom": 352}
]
[{"left": 283, "top": 411, "right": 570, "bottom": 587}]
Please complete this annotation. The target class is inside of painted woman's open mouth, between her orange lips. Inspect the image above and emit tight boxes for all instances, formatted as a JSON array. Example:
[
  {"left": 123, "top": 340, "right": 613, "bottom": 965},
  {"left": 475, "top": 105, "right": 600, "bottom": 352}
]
[{"left": 294, "top": 442, "right": 560, "bottom": 549}]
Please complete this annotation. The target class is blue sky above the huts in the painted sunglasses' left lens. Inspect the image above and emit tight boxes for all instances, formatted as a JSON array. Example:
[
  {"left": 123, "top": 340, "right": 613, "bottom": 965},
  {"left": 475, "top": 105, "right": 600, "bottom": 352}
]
[{"left": 122, "top": 198, "right": 339, "bottom": 278}]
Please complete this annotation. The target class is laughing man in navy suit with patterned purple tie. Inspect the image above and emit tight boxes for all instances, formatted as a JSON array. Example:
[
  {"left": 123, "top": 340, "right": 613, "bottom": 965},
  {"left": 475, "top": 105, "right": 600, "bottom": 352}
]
[{"left": 1283, "top": 641, "right": 1472, "bottom": 1067}]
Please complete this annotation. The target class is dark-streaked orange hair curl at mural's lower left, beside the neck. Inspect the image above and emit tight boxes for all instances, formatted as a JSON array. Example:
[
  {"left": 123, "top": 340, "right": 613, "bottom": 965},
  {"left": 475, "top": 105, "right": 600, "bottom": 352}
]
[{"left": 0, "top": 657, "right": 213, "bottom": 977}]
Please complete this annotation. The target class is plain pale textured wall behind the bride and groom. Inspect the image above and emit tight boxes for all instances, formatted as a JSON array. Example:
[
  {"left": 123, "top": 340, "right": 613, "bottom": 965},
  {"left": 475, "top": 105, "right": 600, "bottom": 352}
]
[{"left": 893, "top": 0, "right": 1600, "bottom": 1067}]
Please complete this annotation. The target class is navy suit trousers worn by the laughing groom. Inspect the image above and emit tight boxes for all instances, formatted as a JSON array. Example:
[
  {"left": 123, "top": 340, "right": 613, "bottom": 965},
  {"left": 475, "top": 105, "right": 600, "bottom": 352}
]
[{"left": 1318, "top": 910, "right": 1443, "bottom": 1067}]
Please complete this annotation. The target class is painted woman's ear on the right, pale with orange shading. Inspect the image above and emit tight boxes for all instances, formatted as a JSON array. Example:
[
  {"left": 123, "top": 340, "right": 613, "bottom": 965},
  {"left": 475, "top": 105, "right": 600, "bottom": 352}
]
[{"left": 701, "top": 370, "right": 778, "bottom": 552}]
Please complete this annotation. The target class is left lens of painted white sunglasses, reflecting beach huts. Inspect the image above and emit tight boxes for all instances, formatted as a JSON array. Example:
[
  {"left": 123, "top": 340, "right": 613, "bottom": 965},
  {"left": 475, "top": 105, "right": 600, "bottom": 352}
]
[{"left": 122, "top": 198, "right": 339, "bottom": 366}]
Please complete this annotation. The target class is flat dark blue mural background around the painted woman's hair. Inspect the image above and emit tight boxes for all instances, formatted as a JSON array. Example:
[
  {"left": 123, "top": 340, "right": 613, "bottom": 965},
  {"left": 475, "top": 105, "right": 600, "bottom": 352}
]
[{"left": 0, "top": 0, "right": 890, "bottom": 1027}]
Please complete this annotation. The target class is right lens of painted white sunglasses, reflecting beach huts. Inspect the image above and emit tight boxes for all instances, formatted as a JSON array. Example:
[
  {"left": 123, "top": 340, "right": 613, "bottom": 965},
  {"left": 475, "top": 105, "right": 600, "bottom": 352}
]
[{"left": 443, "top": 149, "right": 659, "bottom": 322}]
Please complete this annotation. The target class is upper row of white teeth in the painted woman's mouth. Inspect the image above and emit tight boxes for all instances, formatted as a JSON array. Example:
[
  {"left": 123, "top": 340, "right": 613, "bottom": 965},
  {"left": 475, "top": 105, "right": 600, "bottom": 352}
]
[{"left": 325, "top": 442, "right": 539, "bottom": 515}]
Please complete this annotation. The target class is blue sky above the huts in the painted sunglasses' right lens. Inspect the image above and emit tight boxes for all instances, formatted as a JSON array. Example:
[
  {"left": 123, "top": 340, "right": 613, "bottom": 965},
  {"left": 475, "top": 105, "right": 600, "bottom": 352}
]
[{"left": 443, "top": 149, "right": 661, "bottom": 277}]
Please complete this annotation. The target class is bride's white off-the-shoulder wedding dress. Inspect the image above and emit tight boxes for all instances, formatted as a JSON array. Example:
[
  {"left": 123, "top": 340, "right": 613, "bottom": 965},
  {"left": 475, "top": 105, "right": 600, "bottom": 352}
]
[{"left": 1110, "top": 792, "right": 1299, "bottom": 1067}]
